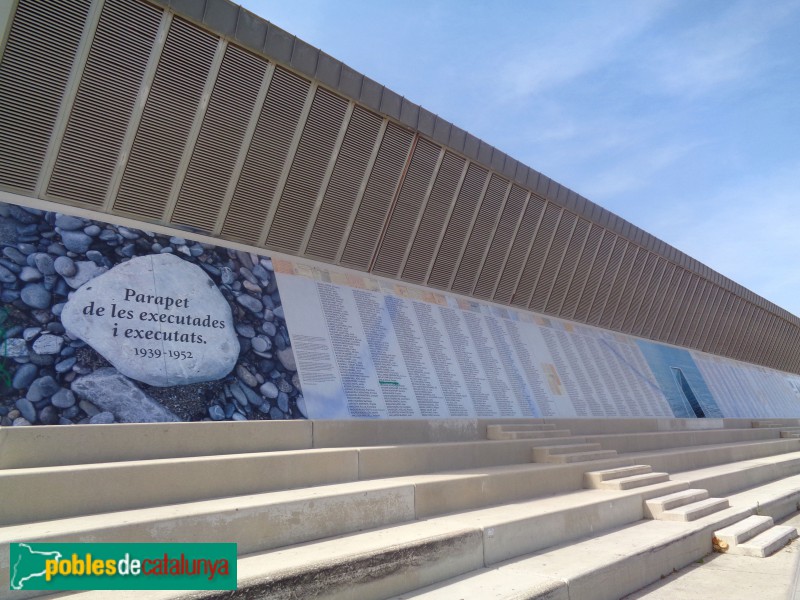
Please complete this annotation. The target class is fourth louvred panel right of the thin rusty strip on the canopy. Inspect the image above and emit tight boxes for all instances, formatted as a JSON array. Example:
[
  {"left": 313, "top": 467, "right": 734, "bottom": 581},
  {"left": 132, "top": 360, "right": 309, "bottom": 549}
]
[{"left": 453, "top": 175, "right": 508, "bottom": 294}]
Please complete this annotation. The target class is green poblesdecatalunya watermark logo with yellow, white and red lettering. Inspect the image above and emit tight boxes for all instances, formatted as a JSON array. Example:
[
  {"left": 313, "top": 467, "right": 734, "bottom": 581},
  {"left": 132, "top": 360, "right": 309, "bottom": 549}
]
[{"left": 9, "top": 543, "right": 236, "bottom": 590}]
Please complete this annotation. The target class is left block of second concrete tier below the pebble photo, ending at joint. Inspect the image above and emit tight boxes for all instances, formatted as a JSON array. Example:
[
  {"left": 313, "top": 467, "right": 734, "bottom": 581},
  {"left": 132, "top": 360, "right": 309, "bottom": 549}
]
[{"left": 0, "top": 450, "right": 358, "bottom": 525}]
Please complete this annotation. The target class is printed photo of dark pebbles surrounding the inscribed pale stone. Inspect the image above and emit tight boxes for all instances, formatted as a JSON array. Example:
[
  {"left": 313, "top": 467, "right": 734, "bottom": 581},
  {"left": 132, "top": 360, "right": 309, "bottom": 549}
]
[{"left": 0, "top": 203, "right": 306, "bottom": 426}]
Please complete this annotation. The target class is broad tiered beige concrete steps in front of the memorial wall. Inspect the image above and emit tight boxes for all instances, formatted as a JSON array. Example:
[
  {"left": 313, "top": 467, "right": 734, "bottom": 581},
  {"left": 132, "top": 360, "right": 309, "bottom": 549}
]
[{"left": 0, "top": 420, "right": 800, "bottom": 600}]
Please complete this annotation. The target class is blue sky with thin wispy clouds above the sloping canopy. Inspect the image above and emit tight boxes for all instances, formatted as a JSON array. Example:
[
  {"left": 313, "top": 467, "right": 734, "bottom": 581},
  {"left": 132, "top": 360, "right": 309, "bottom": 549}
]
[{"left": 242, "top": 0, "right": 800, "bottom": 315}]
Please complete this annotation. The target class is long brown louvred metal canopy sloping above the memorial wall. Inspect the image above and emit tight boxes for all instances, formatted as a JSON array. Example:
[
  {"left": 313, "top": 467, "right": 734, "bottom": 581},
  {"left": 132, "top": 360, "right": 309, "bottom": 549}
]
[{"left": 0, "top": 0, "right": 800, "bottom": 372}]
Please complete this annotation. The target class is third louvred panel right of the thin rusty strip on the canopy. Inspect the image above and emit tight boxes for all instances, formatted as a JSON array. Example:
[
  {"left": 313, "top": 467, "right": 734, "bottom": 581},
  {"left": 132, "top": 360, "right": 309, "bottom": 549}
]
[{"left": 428, "top": 163, "right": 489, "bottom": 289}]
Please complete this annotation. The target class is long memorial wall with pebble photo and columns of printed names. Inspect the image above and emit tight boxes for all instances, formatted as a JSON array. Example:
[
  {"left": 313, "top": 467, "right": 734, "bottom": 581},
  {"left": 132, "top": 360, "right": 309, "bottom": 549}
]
[{"left": 0, "top": 198, "right": 800, "bottom": 425}]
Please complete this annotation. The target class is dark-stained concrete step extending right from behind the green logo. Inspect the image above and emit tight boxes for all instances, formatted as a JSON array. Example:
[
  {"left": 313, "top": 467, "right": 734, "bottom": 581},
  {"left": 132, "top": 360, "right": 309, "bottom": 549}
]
[{"left": 15, "top": 490, "right": 652, "bottom": 598}]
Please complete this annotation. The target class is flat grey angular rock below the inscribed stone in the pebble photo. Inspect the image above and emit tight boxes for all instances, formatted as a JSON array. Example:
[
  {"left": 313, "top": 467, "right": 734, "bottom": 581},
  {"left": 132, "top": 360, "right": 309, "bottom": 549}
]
[{"left": 72, "top": 367, "right": 180, "bottom": 423}]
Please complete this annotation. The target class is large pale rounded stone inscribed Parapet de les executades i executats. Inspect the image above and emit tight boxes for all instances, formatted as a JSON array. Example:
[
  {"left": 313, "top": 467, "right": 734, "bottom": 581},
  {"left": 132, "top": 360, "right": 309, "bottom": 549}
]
[{"left": 61, "top": 254, "right": 239, "bottom": 384}]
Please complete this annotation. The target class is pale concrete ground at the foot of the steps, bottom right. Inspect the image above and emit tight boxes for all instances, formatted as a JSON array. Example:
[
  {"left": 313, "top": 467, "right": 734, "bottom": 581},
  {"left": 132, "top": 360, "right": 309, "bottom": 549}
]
[{"left": 623, "top": 513, "right": 800, "bottom": 600}]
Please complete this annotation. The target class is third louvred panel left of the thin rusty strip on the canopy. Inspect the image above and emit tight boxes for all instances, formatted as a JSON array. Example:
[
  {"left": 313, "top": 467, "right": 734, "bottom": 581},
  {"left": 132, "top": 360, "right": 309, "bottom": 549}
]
[{"left": 267, "top": 88, "right": 347, "bottom": 253}]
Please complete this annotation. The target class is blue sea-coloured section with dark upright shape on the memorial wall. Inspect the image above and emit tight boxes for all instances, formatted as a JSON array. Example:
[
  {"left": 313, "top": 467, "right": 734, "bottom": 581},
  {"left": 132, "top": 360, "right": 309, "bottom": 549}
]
[{"left": 636, "top": 340, "right": 723, "bottom": 419}]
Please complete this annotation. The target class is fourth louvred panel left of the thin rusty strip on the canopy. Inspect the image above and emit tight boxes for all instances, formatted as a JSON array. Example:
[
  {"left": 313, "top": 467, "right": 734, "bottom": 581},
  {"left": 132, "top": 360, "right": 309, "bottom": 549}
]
[{"left": 222, "top": 67, "right": 311, "bottom": 244}]
